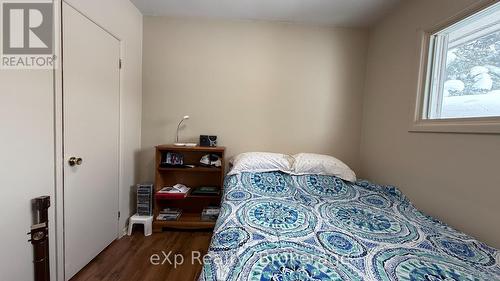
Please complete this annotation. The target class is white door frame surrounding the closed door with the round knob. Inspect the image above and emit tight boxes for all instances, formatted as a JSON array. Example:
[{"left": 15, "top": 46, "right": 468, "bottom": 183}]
[{"left": 52, "top": 0, "right": 124, "bottom": 281}]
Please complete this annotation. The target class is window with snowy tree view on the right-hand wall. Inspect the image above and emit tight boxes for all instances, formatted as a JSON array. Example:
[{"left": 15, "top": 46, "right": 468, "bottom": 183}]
[{"left": 417, "top": 3, "right": 500, "bottom": 132}]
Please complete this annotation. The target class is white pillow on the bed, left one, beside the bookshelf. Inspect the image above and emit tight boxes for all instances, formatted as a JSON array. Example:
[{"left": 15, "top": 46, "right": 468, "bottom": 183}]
[{"left": 228, "top": 152, "right": 293, "bottom": 175}]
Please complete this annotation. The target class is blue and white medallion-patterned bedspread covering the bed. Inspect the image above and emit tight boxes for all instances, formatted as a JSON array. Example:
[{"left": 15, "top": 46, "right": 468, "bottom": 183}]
[{"left": 200, "top": 172, "right": 500, "bottom": 281}]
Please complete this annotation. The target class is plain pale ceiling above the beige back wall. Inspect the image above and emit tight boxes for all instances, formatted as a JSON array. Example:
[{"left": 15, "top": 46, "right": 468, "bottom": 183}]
[{"left": 131, "top": 0, "right": 400, "bottom": 27}]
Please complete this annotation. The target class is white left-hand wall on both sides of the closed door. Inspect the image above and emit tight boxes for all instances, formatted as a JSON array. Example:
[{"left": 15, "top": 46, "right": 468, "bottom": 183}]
[{"left": 0, "top": 0, "right": 142, "bottom": 281}]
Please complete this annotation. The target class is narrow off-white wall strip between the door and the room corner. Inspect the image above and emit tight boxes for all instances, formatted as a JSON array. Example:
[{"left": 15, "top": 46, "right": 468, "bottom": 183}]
[{"left": 66, "top": 0, "right": 142, "bottom": 234}]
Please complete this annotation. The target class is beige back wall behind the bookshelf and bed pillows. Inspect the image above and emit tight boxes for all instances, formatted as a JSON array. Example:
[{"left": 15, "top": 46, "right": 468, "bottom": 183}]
[{"left": 141, "top": 17, "right": 367, "bottom": 180}]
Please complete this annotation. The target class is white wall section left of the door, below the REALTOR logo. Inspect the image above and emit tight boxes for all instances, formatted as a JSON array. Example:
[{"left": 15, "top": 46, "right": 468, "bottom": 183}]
[{"left": 0, "top": 70, "right": 56, "bottom": 281}]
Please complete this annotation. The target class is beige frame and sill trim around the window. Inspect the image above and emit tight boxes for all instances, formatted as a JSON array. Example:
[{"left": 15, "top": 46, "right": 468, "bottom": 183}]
[{"left": 409, "top": 0, "right": 500, "bottom": 134}]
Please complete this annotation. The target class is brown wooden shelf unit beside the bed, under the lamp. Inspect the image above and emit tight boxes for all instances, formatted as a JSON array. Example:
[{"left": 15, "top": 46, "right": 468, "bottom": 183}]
[{"left": 153, "top": 145, "right": 225, "bottom": 232}]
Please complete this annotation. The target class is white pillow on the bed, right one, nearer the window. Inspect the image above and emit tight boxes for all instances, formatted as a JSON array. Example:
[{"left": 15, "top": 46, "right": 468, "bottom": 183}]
[{"left": 292, "top": 153, "right": 356, "bottom": 182}]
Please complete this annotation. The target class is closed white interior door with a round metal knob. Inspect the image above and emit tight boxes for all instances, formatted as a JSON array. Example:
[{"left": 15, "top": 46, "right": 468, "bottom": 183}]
[{"left": 62, "top": 3, "right": 120, "bottom": 280}]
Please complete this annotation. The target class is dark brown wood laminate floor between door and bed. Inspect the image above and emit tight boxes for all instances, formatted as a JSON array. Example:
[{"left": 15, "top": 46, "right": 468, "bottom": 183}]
[{"left": 71, "top": 230, "right": 212, "bottom": 281}]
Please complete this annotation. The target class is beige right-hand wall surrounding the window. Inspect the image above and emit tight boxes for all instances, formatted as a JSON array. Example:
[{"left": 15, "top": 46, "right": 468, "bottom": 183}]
[{"left": 361, "top": 0, "right": 500, "bottom": 245}]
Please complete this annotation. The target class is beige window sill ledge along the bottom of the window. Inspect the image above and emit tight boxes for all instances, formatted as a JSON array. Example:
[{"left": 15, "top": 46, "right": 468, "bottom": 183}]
[{"left": 408, "top": 117, "right": 500, "bottom": 134}]
